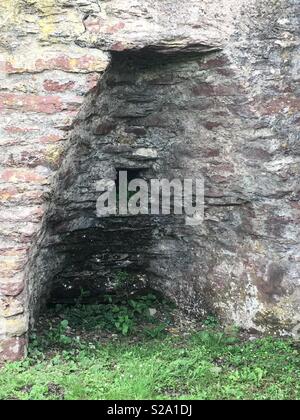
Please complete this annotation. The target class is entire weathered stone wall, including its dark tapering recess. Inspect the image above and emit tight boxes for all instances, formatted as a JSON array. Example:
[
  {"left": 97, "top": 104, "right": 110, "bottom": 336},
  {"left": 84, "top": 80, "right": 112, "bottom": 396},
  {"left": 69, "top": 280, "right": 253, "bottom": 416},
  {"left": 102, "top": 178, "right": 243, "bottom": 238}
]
[{"left": 0, "top": 0, "right": 300, "bottom": 360}]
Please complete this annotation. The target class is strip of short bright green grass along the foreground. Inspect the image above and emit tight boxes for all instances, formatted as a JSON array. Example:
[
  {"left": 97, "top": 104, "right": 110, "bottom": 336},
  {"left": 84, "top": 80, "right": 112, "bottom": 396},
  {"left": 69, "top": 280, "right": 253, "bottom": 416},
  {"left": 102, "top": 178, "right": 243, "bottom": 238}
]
[{"left": 0, "top": 329, "right": 300, "bottom": 400}]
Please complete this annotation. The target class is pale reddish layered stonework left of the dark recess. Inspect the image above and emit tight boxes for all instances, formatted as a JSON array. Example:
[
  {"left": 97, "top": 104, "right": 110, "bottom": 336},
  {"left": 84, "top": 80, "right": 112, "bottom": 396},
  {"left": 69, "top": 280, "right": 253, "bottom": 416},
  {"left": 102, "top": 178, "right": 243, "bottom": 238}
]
[{"left": 0, "top": 0, "right": 109, "bottom": 359}]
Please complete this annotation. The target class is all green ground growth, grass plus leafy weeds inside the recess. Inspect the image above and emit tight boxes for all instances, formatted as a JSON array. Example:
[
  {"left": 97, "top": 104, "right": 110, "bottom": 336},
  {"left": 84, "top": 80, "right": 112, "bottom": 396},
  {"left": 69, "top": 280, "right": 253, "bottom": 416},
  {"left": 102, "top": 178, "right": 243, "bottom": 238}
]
[{"left": 0, "top": 296, "right": 300, "bottom": 400}]
